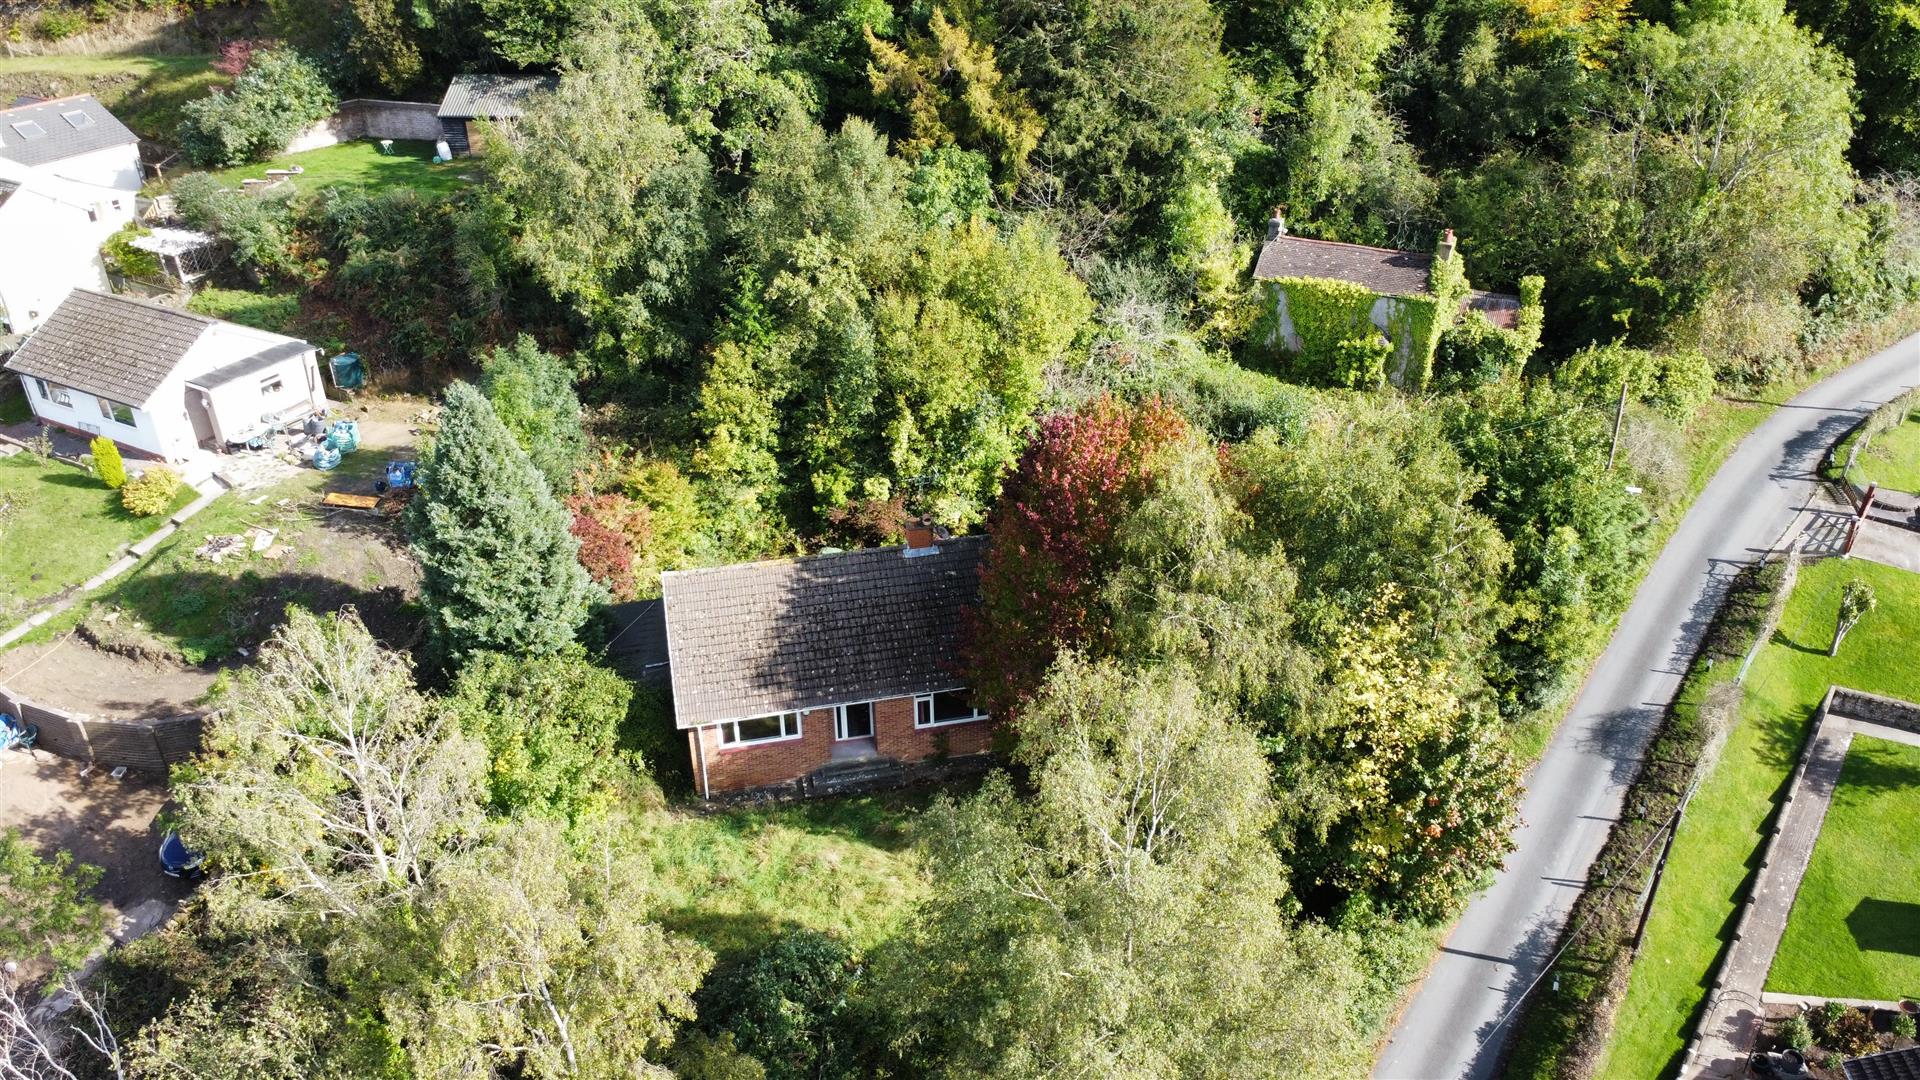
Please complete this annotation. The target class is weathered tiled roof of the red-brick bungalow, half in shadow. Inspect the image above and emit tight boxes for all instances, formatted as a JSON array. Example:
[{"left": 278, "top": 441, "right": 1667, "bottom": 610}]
[{"left": 660, "top": 536, "right": 987, "bottom": 728}]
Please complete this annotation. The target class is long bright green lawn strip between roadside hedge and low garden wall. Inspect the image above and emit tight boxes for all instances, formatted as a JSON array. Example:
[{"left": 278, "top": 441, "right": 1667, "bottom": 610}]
[{"left": 1596, "top": 559, "right": 1920, "bottom": 1076}]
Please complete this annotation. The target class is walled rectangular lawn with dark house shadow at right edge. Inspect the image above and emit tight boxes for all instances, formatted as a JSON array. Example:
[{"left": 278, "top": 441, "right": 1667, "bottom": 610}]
[{"left": 1766, "top": 734, "right": 1920, "bottom": 1001}]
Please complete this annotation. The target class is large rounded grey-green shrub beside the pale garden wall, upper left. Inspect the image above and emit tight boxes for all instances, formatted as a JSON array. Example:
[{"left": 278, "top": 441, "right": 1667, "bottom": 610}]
[{"left": 179, "top": 48, "right": 338, "bottom": 167}]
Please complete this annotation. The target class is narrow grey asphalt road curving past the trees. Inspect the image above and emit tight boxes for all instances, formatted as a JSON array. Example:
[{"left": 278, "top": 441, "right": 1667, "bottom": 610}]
[{"left": 1373, "top": 336, "right": 1920, "bottom": 1080}]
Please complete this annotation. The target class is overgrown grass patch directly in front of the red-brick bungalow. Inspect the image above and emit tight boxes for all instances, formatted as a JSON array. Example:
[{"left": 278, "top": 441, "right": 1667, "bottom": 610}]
[{"left": 643, "top": 788, "right": 933, "bottom": 955}]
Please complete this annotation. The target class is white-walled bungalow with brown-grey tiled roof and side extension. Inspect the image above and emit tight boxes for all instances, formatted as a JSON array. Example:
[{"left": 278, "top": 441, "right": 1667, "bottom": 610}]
[{"left": 6, "top": 288, "right": 326, "bottom": 461}]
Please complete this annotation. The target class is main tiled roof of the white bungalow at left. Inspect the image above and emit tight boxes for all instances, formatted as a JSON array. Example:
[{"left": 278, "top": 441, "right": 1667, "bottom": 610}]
[{"left": 6, "top": 288, "right": 213, "bottom": 405}]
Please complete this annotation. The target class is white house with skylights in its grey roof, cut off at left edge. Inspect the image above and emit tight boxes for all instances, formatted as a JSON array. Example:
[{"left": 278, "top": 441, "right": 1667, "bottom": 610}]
[{"left": 0, "top": 94, "right": 140, "bottom": 334}]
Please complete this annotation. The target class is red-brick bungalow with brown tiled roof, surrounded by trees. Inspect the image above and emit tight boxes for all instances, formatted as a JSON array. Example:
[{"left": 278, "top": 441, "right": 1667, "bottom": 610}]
[{"left": 660, "top": 525, "right": 993, "bottom": 798}]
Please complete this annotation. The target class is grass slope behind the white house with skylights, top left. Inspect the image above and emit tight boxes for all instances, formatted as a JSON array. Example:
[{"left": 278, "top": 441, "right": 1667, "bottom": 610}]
[{"left": 0, "top": 56, "right": 232, "bottom": 144}]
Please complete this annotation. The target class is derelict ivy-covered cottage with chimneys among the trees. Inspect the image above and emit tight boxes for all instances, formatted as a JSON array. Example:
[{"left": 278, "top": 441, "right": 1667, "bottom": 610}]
[{"left": 1254, "top": 209, "right": 1542, "bottom": 390}]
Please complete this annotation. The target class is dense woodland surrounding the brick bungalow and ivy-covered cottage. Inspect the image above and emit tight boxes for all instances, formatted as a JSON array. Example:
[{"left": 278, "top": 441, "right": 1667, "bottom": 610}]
[{"left": 11, "top": 0, "right": 1920, "bottom": 1078}]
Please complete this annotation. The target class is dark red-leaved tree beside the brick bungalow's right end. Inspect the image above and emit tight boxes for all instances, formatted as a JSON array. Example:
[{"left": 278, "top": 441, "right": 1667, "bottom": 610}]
[{"left": 968, "top": 398, "right": 1187, "bottom": 717}]
